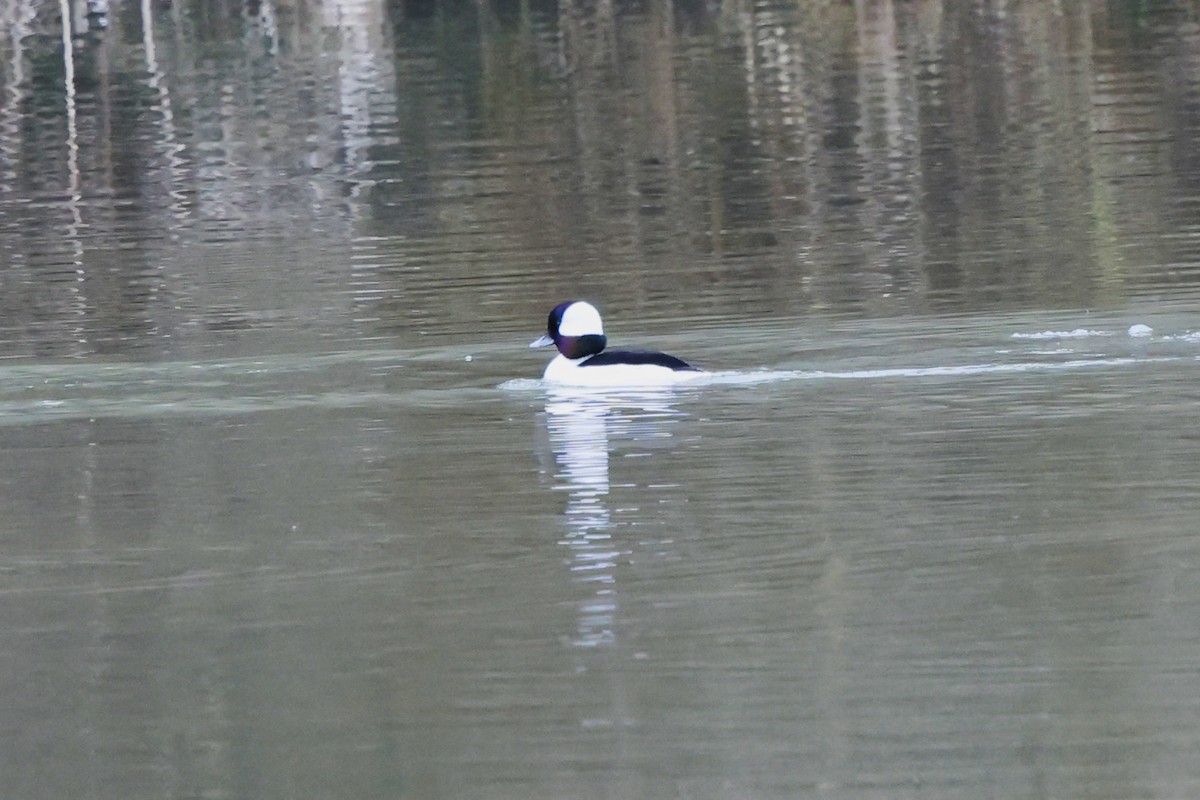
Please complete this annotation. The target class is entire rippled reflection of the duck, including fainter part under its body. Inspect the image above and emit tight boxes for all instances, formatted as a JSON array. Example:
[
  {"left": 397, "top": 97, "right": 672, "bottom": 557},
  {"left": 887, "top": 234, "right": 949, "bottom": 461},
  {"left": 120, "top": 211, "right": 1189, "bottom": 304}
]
[{"left": 545, "top": 387, "right": 683, "bottom": 648}]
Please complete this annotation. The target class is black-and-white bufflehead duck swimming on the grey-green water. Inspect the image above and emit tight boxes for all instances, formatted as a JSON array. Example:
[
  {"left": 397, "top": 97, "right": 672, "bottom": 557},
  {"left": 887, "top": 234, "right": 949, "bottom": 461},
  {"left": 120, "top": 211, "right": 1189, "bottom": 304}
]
[{"left": 529, "top": 300, "right": 704, "bottom": 386}]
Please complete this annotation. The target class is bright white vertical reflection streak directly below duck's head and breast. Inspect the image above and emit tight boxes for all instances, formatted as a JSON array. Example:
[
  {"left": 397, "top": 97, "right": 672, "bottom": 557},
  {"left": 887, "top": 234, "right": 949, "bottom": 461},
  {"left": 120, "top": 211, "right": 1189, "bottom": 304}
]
[{"left": 546, "top": 395, "right": 619, "bottom": 646}]
